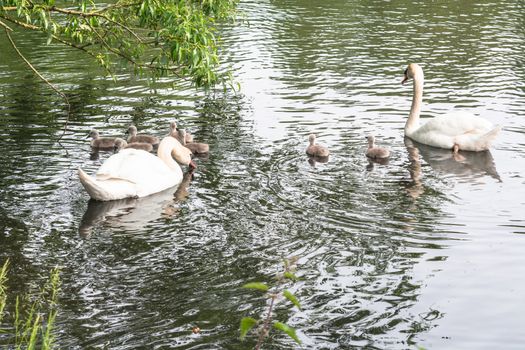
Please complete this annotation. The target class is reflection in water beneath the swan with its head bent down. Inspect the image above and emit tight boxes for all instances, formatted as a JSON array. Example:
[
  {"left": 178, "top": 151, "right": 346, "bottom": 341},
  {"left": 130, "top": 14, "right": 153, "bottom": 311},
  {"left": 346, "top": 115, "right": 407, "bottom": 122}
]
[{"left": 78, "top": 172, "right": 193, "bottom": 237}]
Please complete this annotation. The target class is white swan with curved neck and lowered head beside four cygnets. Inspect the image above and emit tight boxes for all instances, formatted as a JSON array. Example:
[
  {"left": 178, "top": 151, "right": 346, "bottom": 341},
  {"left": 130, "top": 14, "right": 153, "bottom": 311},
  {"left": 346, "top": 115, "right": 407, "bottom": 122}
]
[{"left": 78, "top": 136, "right": 195, "bottom": 201}]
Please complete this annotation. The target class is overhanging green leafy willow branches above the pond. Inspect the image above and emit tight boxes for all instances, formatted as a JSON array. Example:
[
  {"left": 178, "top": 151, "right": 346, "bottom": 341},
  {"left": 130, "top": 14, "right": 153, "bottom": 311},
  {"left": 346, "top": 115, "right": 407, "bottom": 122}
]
[{"left": 0, "top": 0, "right": 238, "bottom": 87}]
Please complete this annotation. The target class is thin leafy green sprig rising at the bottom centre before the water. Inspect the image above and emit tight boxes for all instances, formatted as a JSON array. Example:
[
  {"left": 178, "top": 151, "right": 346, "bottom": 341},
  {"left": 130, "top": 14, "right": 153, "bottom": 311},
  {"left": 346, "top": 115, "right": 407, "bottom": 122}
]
[{"left": 240, "top": 257, "right": 301, "bottom": 349}]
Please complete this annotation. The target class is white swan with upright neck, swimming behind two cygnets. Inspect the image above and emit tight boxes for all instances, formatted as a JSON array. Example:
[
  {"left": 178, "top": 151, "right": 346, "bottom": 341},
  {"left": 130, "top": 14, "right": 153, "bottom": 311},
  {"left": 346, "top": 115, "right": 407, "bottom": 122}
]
[{"left": 401, "top": 63, "right": 501, "bottom": 153}]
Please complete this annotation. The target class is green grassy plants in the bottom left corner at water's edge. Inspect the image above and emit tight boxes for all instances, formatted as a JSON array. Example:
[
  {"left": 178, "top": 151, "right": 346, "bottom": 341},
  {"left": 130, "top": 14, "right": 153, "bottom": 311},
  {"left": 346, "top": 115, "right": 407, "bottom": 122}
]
[{"left": 0, "top": 260, "right": 60, "bottom": 350}]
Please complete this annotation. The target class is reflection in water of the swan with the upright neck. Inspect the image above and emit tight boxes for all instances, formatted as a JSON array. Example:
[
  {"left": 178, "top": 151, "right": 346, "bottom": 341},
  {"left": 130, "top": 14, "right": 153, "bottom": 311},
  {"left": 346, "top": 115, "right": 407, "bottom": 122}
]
[{"left": 405, "top": 137, "right": 501, "bottom": 198}]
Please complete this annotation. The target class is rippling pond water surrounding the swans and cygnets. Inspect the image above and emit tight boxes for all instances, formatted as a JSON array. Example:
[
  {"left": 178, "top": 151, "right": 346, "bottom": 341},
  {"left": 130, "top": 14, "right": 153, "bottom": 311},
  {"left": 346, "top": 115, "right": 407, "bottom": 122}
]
[{"left": 0, "top": 0, "right": 525, "bottom": 349}]
